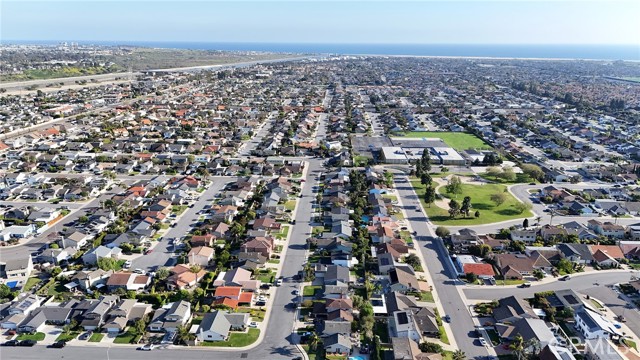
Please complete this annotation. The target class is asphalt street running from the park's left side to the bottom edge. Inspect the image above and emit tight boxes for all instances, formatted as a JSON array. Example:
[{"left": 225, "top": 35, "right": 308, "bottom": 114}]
[{"left": 394, "top": 175, "right": 489, "bottom": 359}]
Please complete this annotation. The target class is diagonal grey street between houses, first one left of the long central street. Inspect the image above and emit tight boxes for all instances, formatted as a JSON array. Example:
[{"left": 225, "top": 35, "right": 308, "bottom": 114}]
[{"left": 131, "top": 177, "right": 233, "bottom": 271}]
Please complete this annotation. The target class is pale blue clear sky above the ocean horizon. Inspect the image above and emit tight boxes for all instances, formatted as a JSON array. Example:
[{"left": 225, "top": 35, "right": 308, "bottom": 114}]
[{"left": 0, "top": 0, "right": 640, "bottom": 45}]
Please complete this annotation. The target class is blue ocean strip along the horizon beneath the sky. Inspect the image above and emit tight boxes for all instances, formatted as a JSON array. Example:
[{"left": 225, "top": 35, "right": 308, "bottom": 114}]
[{"left": 4, "top": 40, "right": 640, "bottom": 61}]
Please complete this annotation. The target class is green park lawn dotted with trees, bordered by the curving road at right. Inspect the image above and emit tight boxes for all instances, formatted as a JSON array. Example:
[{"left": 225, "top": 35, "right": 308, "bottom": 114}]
[{"left": 411, "top": 179, "right": 532, "bottom": 226}]
